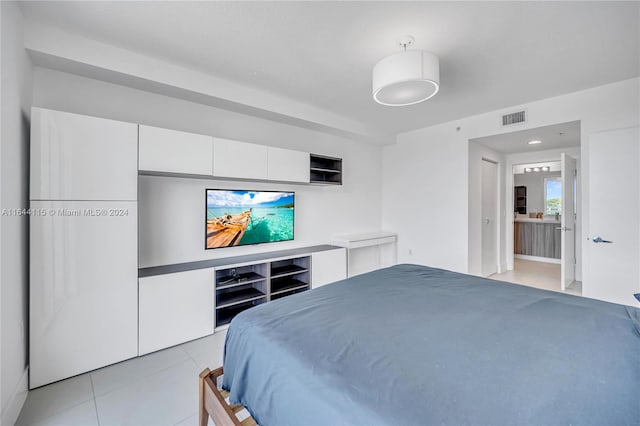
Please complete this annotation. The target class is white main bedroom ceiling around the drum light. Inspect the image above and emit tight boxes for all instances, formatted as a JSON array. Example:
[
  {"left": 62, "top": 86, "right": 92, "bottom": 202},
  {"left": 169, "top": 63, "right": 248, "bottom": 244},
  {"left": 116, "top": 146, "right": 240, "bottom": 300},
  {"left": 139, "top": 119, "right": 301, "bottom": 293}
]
[{"left": 21, "top": 1, "right": 640, "bottom": 134}]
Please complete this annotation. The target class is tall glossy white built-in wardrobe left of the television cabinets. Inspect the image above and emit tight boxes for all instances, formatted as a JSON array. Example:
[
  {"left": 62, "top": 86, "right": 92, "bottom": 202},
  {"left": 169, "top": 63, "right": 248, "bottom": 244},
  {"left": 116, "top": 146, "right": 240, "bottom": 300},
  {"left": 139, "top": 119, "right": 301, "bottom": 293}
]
[{"left": 29, "top": 108, "right": 138, "bottom": 388}]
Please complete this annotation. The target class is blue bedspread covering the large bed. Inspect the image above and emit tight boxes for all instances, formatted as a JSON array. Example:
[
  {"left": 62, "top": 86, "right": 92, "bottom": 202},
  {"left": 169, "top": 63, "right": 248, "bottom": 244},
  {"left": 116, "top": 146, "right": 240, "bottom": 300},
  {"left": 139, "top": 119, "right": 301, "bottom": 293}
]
[{"left": 223, "top": 265, "right": 640, "bottom": 426}]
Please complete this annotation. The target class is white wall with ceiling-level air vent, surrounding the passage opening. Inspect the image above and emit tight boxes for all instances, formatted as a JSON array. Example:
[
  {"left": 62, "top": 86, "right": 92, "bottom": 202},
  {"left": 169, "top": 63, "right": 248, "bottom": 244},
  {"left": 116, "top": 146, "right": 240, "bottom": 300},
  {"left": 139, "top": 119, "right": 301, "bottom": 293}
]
[{"left": 382, "top": 78, "right": 640, "bottom": 288}]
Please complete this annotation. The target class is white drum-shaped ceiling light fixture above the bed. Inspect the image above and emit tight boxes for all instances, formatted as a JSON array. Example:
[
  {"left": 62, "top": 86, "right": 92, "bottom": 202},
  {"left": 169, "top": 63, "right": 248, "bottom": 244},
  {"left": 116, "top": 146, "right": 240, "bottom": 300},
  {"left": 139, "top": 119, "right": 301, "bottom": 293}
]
[{"left": 373, "top": 36, "right": 440, "bottom": 106}]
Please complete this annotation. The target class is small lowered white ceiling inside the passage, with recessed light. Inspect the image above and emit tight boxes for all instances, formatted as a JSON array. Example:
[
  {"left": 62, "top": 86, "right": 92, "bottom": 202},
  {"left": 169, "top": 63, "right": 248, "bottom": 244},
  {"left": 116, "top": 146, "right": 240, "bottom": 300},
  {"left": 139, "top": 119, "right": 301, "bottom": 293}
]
[{"left": 471, "top": 121, "right": 580, "bottom": 154}]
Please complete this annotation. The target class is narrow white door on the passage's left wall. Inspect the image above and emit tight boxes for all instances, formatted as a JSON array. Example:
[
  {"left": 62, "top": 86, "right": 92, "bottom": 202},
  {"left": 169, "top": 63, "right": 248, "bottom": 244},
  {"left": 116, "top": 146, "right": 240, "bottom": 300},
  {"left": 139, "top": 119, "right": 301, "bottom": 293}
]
[{"left": 481, "top": 160, "right": 498, "bottom": 277}]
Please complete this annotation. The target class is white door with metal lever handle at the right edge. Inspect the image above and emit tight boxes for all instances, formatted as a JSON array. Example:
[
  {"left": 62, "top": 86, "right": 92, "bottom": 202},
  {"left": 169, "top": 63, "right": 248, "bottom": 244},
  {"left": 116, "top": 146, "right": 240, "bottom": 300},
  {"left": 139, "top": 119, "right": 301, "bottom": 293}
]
[{"left": 582, "top": 127, "right": 640, "bottom": 306}]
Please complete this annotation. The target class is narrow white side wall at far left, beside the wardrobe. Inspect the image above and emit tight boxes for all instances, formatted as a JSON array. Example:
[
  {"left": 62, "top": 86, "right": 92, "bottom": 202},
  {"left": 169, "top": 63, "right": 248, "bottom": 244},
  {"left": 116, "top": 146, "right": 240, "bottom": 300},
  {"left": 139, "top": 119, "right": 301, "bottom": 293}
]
[{"left": 0, "top": 2, "right": 32, "bottom": 424}]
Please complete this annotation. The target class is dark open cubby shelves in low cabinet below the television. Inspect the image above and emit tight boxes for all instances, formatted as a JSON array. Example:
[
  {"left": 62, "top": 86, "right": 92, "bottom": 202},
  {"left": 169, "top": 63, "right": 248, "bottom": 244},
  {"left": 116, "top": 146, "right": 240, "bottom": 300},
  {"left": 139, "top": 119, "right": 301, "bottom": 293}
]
[{"left": 215, "top": 256, "right": 311, "bottom": 328}]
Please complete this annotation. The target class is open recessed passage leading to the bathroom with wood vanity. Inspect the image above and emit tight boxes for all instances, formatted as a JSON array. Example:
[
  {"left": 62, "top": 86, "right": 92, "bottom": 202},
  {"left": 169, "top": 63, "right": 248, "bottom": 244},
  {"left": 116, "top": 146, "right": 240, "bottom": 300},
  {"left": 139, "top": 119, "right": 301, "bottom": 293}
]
[{"left": 469, "top": 121, "right": 581, "bottom": 294}]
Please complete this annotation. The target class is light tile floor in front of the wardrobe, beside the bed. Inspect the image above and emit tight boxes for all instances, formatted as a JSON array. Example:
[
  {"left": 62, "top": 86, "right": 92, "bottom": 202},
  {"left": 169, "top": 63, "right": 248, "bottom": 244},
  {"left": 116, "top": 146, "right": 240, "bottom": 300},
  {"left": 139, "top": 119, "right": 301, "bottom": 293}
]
[{"left": 16, "top": 332, "right": 226, "bottom": 426}]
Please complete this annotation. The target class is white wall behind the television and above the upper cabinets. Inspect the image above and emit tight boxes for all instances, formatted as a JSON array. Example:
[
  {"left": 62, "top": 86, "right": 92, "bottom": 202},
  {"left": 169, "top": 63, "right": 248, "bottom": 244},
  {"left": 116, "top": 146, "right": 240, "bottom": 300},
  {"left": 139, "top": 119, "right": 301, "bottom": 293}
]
[{"left": 33, "top": 67, "right": 381, "bottom": 267}]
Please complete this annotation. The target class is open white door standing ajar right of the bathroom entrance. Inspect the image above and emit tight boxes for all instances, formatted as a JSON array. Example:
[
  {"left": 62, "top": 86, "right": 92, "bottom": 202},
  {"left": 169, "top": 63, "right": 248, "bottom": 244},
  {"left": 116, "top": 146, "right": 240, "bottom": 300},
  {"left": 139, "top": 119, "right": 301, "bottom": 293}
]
[{"left": 560, "top": 152, "right": 577, "bottom": 290}]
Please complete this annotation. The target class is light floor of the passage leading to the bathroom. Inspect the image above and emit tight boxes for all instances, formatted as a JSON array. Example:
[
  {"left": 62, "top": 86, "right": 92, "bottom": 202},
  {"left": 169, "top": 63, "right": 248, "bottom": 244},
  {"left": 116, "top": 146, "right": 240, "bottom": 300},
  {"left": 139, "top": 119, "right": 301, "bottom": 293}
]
[{"left": 489, "top": 259, "right": 582, "bottom": 296}]
